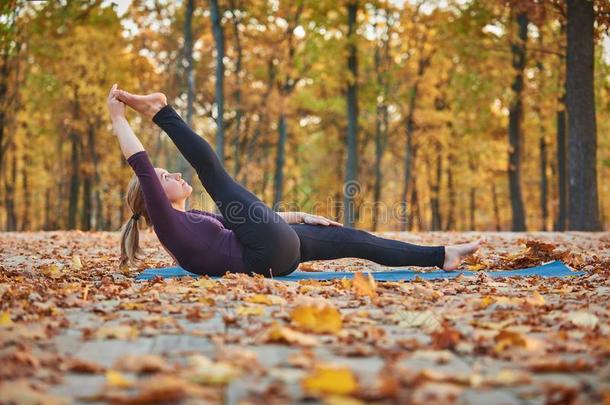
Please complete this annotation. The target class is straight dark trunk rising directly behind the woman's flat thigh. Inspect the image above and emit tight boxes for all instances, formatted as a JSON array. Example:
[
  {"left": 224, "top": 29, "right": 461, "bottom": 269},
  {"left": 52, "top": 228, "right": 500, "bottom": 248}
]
[{"left": 343, "top": 0, "right": 360, "bottom": 226}]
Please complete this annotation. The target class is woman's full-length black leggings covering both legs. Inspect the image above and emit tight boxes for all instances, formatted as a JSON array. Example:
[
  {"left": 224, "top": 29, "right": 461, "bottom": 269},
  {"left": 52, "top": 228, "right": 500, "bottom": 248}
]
[{"left": 153, "top": 105, "right": 445, "bottom": 276}]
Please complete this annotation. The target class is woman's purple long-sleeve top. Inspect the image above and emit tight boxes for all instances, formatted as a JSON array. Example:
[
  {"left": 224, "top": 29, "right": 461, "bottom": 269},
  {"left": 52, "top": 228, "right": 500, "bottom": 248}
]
[{"left": 127, "top": 151, "right": 248, "bottom": 275}]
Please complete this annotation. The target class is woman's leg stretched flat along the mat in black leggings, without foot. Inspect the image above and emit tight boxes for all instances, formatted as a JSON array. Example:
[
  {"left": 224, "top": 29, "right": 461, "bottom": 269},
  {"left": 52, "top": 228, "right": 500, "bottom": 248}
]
[{"left": 291, "top": 224, "right": 445, "bottom": 268}]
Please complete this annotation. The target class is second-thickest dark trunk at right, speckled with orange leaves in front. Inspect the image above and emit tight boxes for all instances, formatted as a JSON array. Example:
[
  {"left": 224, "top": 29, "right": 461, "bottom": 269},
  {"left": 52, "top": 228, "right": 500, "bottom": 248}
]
[{"left": 508, "top": 13, "right": 528, "bottom": 232}]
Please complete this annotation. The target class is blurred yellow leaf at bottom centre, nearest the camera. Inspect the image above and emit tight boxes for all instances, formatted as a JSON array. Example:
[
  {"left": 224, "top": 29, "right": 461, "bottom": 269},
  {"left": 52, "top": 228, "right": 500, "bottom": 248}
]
[{"left": 301, "top": 365, "right": 358, "bottom": 395}]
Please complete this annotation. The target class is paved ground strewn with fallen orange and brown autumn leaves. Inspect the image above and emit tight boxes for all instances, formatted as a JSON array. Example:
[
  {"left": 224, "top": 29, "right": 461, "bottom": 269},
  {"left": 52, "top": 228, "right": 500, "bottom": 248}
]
[{"left": 0, "top": 232, "right": 610, "bottom": 404}]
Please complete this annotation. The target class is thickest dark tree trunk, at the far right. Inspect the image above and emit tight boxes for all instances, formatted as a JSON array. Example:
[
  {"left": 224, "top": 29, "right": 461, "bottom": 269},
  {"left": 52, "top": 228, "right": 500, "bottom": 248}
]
[{"left": 566, "top": 0, "right": 602, "bottom": 231}]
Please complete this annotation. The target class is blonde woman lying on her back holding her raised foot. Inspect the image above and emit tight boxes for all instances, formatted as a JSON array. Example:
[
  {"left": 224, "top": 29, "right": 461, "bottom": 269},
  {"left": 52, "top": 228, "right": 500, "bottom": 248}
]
[{"left": 108, "top": 84, "right": 481, "bottom": 277}]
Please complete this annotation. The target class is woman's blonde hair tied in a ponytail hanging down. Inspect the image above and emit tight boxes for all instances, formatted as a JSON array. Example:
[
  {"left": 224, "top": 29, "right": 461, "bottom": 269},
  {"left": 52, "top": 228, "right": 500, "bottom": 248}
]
[{"left": 119, "top": 175, "right": 150, "bottom": 267}]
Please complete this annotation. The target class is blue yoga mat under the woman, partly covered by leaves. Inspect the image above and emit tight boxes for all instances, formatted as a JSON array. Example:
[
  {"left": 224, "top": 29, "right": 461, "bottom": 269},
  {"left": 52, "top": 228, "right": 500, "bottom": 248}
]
[{"left": 136, "top": 260, "right": 584, "bottom": 281}]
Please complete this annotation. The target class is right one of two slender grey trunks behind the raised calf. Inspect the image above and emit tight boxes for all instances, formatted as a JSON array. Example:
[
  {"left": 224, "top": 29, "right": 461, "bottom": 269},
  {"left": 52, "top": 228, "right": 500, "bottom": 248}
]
[{"left": 210, "top": 0, "right": 225, "bottom": 164}]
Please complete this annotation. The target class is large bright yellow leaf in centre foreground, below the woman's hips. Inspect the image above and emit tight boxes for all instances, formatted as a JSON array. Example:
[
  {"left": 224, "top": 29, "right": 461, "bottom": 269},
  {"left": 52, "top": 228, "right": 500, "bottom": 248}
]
[{"left": 290, "top": 305, "right": 342, "bottom": 333}]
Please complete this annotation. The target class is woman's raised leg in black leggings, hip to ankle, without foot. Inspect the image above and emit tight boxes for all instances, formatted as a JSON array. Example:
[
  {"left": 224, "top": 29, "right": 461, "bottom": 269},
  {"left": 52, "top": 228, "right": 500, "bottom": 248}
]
[{"left": 153, "top": 105, "right": 299, "bottom": 275}]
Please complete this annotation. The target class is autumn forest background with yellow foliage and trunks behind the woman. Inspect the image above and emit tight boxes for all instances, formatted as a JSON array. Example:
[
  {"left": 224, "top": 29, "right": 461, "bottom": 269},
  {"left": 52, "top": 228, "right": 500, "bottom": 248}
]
[{"left": 0, "top": 0, "right": 610, "bottom": 231}]
